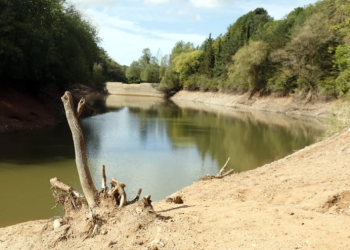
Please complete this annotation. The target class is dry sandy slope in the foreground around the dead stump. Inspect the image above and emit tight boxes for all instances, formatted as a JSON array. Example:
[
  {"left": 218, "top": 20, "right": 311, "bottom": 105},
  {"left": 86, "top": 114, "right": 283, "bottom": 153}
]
[{"left": 0, "top": 127, "right": 350, "bottom": 250}]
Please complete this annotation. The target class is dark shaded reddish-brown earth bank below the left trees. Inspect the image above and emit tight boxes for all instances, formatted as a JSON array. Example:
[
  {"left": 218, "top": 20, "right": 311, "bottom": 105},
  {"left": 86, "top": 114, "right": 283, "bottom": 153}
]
[{"left": 0, "top": 86, "right": 93, "bottom": 133}]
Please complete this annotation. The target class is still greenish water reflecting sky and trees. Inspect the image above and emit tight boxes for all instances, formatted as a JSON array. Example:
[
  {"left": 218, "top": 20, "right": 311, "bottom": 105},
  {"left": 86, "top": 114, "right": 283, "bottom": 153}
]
[{"left": 0, "top": 96, "right": 322, "bottom": 227}]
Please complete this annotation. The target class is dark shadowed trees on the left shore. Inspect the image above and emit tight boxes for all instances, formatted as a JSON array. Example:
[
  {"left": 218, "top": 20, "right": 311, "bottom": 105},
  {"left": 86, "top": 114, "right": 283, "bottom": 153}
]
[{"left": 0, "top": 0, "right": 125, "bottom": 89}]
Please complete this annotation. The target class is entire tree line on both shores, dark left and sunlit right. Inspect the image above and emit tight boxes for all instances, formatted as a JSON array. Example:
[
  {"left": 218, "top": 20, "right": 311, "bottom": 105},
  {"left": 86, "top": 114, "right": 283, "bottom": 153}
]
[{"left": 0, "top": 0, "right": 350, "bottom": 97}]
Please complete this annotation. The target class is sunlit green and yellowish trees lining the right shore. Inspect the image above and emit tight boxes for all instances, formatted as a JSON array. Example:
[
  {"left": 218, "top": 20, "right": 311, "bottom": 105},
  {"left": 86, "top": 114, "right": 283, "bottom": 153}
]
[{"left": 126, "top": 0, "right": 350, "bottom": 98}]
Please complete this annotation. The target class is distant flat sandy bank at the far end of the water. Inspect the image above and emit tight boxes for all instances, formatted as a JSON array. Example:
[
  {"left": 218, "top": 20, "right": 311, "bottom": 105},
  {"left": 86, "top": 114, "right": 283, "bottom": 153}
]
[{"left": 106, "top": 82, "right": 163, "bottom": 97}]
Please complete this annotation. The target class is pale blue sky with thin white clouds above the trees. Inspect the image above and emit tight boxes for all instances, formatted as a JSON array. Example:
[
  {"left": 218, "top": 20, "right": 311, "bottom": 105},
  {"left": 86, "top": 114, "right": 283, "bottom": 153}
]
[{"left": 70, "top": 0, "right": 316, "bottom": 65}]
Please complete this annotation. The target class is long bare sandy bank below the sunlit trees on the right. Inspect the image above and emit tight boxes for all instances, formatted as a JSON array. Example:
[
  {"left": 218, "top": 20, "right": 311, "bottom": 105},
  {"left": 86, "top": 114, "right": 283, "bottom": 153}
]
[{"left": 171, "top": 90, "right": 339, "bottom": 119}]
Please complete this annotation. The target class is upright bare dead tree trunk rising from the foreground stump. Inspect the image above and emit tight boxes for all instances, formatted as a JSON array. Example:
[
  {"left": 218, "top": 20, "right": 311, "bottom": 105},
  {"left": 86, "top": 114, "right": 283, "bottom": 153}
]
[{"left": 61, "top": 91, "right": 97, "bottom": 208}]
